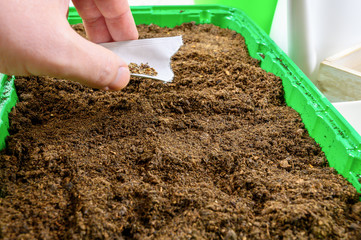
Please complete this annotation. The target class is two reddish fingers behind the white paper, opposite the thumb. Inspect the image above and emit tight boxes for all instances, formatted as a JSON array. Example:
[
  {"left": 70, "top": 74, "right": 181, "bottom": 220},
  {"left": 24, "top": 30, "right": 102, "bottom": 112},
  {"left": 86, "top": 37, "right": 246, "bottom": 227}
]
[{"left": 73, "top": 0, "right": 138, "bottom": 43}]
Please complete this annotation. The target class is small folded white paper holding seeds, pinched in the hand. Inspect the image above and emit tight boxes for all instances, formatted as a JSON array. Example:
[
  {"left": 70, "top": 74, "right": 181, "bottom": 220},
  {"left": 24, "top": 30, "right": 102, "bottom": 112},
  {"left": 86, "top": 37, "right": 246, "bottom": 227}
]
[{"left": 100, "top": 36, "right": 183, "bottom": 82}]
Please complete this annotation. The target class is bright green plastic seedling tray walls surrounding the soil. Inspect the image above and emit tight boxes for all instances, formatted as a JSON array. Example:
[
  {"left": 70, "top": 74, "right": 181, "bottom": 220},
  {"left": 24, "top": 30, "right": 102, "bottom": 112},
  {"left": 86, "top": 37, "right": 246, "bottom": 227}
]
[{"left": 1, "top": 5, "right": 361, "bottom": 192}]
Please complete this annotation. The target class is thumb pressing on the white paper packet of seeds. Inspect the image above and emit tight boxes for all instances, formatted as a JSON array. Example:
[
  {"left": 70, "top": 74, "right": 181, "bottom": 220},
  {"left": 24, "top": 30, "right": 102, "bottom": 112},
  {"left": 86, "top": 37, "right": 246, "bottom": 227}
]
[{"left": 55, "top": 25, "right": 130, "bottom": 90}]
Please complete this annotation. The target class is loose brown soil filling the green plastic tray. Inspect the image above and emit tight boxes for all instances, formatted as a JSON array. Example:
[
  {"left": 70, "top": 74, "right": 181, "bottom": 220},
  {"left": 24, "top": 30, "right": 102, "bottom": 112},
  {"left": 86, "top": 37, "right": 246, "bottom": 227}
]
[{"left": 0, "top": 24, "right": 361, "bottom": 240}]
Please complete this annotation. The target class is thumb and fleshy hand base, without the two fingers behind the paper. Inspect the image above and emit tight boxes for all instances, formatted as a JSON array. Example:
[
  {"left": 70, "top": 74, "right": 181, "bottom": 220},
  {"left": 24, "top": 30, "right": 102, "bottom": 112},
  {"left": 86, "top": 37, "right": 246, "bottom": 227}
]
[{"left": 0, "top": 0, "right": 130, "bottom": 90}]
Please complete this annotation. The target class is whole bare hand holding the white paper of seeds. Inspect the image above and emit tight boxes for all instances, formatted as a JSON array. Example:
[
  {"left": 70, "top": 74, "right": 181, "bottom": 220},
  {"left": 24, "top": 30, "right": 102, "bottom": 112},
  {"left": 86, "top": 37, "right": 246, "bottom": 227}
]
[{"left": 0, "top": 0, "right": 138, "bottom": 90}]
